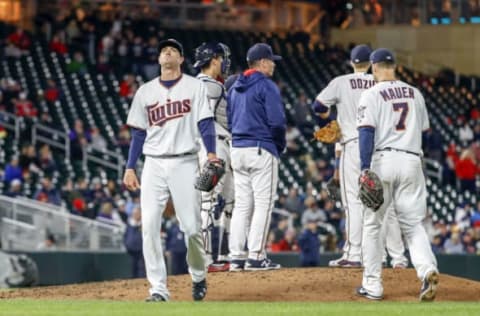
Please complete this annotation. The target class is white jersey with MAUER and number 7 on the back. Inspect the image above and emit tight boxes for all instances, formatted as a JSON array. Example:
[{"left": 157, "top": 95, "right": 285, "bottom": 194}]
[{"left": 357, "top": 80, "right": 430, "bottom": 154}]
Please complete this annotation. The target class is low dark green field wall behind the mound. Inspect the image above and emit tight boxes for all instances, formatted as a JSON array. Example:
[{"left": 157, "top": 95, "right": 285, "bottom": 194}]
[{"left": 14, "top": 252, "right": 480, "bottom": 285}]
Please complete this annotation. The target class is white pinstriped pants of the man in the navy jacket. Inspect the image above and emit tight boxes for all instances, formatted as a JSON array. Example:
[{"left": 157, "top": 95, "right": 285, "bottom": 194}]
[{"left": 229, "top": 147, "right": 278, "bottom": 260}]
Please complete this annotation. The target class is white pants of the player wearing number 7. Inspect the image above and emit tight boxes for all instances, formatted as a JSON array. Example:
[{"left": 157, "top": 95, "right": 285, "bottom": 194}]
[{"left": 362, "top": 151, "right": 438, "bottom": 296}]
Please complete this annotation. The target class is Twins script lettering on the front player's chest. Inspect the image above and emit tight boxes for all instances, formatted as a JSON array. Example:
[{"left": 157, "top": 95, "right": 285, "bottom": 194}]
[{"left": 147, "top": 99, "right": 192, "bottom": 126}]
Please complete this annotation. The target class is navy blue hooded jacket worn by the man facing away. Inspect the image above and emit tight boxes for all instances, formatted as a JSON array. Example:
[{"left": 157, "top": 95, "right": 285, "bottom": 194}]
[{"left": 227, "top": 69, "right": 286, "bottom": 157}]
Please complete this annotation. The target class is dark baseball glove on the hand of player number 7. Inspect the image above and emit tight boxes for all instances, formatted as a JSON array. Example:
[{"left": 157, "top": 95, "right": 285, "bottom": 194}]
[{"left": 358, "top": 169, "right": 383, "bottom": 212}]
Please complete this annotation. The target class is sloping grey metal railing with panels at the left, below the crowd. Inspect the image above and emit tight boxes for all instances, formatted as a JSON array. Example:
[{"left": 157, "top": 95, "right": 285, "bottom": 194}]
[{"left": 0, "top": 196, "right": 124, "bottom": 252}]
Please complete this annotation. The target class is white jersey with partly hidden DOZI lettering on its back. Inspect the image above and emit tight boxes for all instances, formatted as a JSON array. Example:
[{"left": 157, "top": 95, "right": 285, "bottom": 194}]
[{"left": 317, "top": 73, "right": 375, "bottom": 142}]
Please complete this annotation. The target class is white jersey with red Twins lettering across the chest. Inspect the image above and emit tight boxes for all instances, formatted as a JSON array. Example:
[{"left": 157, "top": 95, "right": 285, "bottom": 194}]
[{"left": 127, "top": 74, "right": 213, "bottom": 156}]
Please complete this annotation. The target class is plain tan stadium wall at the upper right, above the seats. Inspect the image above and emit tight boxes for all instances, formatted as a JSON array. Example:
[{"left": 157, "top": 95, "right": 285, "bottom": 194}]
[{"left": 331, "top": 24, "right": 480, "bottom": 75}]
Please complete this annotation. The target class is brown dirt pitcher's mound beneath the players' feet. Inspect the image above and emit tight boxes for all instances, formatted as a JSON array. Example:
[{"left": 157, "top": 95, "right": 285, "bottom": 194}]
[{"left": 0, "top": 268, "right": 480, "bottom": 302}]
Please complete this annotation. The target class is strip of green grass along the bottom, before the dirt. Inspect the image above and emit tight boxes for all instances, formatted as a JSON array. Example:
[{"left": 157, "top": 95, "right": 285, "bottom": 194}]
[{"left": 0, "top": 299, "right": 480, "bottom": 316}]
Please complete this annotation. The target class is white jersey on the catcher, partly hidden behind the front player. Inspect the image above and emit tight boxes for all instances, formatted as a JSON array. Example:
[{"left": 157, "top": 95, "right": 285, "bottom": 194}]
[{"left": 197, "top": 73, "right": 230, "bottom": 136}]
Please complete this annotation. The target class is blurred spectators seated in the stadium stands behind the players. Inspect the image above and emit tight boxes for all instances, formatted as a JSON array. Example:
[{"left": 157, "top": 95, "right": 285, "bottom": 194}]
[{"left": 0, "top": 1, "right": 480, "bottom": 264}]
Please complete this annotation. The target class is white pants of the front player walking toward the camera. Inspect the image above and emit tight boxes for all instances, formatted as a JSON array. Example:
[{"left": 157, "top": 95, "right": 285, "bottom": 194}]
[{"left": 140, "top": 155, "right": 206, "bottom": 299}]
